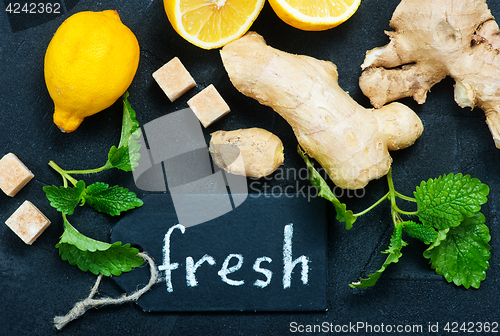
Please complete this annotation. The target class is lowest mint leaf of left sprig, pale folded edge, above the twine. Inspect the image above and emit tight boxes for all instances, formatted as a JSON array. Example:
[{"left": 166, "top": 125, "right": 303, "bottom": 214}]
[{"left": 56, "top": 218, "right": 144, "bottom": 276}]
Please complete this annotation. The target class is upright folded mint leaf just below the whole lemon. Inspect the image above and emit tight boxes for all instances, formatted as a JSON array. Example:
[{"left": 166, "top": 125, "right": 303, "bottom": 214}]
[{"left": 106, "top": 92, "right": 141, "bottom": 171}]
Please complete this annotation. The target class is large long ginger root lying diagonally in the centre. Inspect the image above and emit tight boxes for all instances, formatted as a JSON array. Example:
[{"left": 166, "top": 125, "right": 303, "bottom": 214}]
[{"left": 221, "top": 32, "right": 423, "bottom": 189}]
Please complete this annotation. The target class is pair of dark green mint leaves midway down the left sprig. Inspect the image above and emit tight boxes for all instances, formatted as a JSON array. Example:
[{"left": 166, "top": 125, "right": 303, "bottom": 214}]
[{"left": 43, "top": 180, "right": 143, "bottom": 216}]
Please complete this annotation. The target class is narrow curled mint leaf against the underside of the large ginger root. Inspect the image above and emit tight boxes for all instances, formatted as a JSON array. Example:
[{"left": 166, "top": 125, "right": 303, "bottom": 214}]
[{"left": 297, "top": 146, "right": 356, "bottom": 229}]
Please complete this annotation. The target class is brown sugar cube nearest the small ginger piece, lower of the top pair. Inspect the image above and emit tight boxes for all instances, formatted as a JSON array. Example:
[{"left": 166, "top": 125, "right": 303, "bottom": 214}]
[{"left": 188, "top": 84, "right": 230, "bottom": 127}]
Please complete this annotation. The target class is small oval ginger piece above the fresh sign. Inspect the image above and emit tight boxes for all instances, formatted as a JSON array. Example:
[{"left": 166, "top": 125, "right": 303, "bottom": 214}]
[{"left": 210, "top": 128, "right": 284, "bottom": 178}]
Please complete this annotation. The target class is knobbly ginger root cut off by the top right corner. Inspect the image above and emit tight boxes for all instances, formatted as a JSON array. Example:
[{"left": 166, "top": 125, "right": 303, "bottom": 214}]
[{"left": 359, "top": 0, "right": 500, "bottom": 148}]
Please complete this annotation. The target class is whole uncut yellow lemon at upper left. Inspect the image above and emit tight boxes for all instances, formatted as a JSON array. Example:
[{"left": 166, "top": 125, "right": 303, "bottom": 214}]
[{"left": 44, "top": 10, "right": 140, "bottom": 133}]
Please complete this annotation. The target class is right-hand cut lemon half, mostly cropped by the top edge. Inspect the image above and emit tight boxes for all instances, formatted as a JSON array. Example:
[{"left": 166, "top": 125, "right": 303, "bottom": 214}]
[{"left": 269, "top": 0, "right": 361, "bottom": 30}]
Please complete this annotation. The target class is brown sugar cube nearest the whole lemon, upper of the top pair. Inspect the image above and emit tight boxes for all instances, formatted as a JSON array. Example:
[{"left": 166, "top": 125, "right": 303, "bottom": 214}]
[{"left": 153, "top": 57, "right": 196, "bottom": 102}]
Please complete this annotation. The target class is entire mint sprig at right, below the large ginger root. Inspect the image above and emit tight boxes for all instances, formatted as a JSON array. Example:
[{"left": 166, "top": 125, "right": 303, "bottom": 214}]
[{"left": 299, "top": 152, "right": 491, "bottom": 288}]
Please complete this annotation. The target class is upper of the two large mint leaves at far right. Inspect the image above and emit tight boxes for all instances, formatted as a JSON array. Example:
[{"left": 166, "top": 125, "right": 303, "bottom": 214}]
[{"left": 414, "top": 174, "right": 489, "bottom": 230}]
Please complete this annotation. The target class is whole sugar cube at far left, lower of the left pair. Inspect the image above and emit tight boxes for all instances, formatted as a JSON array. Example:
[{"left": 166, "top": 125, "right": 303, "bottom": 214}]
[{"left": 5, "top": 201, "right": 50, "bottom": 245}]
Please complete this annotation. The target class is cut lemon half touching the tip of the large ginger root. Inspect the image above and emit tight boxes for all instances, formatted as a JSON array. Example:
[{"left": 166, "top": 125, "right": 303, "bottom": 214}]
[{"left": 163, "top": 0, "right": 265, "bottom": 49}]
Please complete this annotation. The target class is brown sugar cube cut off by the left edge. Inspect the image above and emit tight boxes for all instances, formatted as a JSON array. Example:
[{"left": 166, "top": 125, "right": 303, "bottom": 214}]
[{"left": 0, "top": 153, "right": 34, "bottom": 197}]
